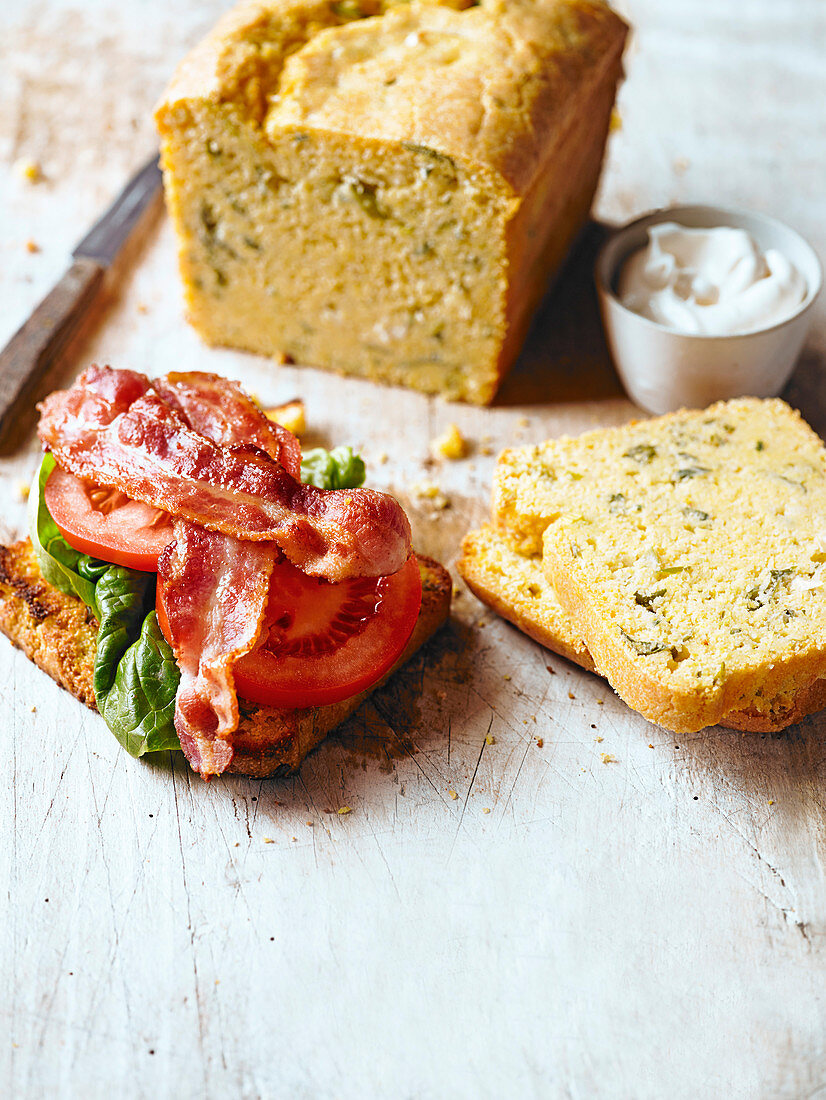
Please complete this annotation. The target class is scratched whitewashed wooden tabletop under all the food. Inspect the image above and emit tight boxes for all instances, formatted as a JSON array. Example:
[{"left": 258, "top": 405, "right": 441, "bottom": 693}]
[{"left": 0, "top": 0, "right": 826, "bottom": 1098}]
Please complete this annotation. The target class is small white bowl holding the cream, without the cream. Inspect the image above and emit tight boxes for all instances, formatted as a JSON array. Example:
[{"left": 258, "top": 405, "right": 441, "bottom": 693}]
[{"left": 596, "top": 206, "right": 823, "bottom": 413}]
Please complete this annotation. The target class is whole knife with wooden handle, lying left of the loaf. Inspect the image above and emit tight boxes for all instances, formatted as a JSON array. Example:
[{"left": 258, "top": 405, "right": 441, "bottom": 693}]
[{"left": 0, "top": 156, "right": 162, "bottom": 454}]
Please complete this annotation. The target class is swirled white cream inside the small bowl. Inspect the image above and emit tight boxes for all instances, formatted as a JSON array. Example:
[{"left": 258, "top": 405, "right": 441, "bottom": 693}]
[{"left": 618, "top": 221, "right": 806, "bottom": 336}]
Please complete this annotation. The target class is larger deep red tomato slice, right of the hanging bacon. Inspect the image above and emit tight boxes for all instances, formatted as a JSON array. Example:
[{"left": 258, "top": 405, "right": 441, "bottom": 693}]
[{"left": 157, "top": 557, "right": 421, "bottom": 708}]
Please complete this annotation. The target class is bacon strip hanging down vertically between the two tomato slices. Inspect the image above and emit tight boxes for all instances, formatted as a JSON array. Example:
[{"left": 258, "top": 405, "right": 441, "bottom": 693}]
[{"left": 158, "top": 519, "right": 277, "bottom": 779}]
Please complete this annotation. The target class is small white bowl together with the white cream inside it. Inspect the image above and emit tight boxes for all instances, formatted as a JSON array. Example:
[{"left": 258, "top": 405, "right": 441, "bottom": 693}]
[{"left": 595, "top": 206, "right": 823, "bottom": 413}]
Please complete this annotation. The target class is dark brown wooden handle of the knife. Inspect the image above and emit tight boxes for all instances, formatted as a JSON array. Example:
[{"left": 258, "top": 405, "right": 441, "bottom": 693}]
[{"left": 0, "top": 257, "right": 104, "bottom": 454}]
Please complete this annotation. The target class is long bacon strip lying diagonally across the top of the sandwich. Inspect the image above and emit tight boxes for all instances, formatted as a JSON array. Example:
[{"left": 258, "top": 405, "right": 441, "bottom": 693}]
[{"left": 38, "top": 366, "right": 410, "bottom": 581}]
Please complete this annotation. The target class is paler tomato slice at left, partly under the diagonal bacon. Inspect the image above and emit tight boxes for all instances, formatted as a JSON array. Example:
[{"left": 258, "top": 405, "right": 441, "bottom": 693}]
[{"left": 44, "top": 466, "right": 175, "bottom": 572}]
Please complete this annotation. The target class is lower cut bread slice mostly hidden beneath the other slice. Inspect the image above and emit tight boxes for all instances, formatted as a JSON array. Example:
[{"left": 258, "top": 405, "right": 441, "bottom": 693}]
[{"left": 456, "top": 525, "right": 826, "bottom": 734}]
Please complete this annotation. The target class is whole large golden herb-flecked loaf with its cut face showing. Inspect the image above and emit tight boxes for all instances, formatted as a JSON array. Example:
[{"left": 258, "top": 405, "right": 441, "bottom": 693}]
[{"left": 156, "top": 0, "right": 627, "bottom": 404}]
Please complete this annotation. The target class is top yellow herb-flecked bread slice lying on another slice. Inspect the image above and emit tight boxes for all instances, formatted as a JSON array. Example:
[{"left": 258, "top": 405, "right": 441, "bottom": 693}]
[{"left": 494, "top": 398, "right": 826, "bottom": 732}]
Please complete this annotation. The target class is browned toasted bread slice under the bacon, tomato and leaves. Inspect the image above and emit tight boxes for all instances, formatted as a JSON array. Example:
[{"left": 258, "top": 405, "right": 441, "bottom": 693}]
[{"left": 0, "top": 539, "right": 451, "bottom": 778}]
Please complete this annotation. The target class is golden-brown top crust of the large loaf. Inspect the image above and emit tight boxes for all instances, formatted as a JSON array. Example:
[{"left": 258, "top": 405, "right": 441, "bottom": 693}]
[{"left": 158, "top": 0, "right": 628, "bottom": 195}]
